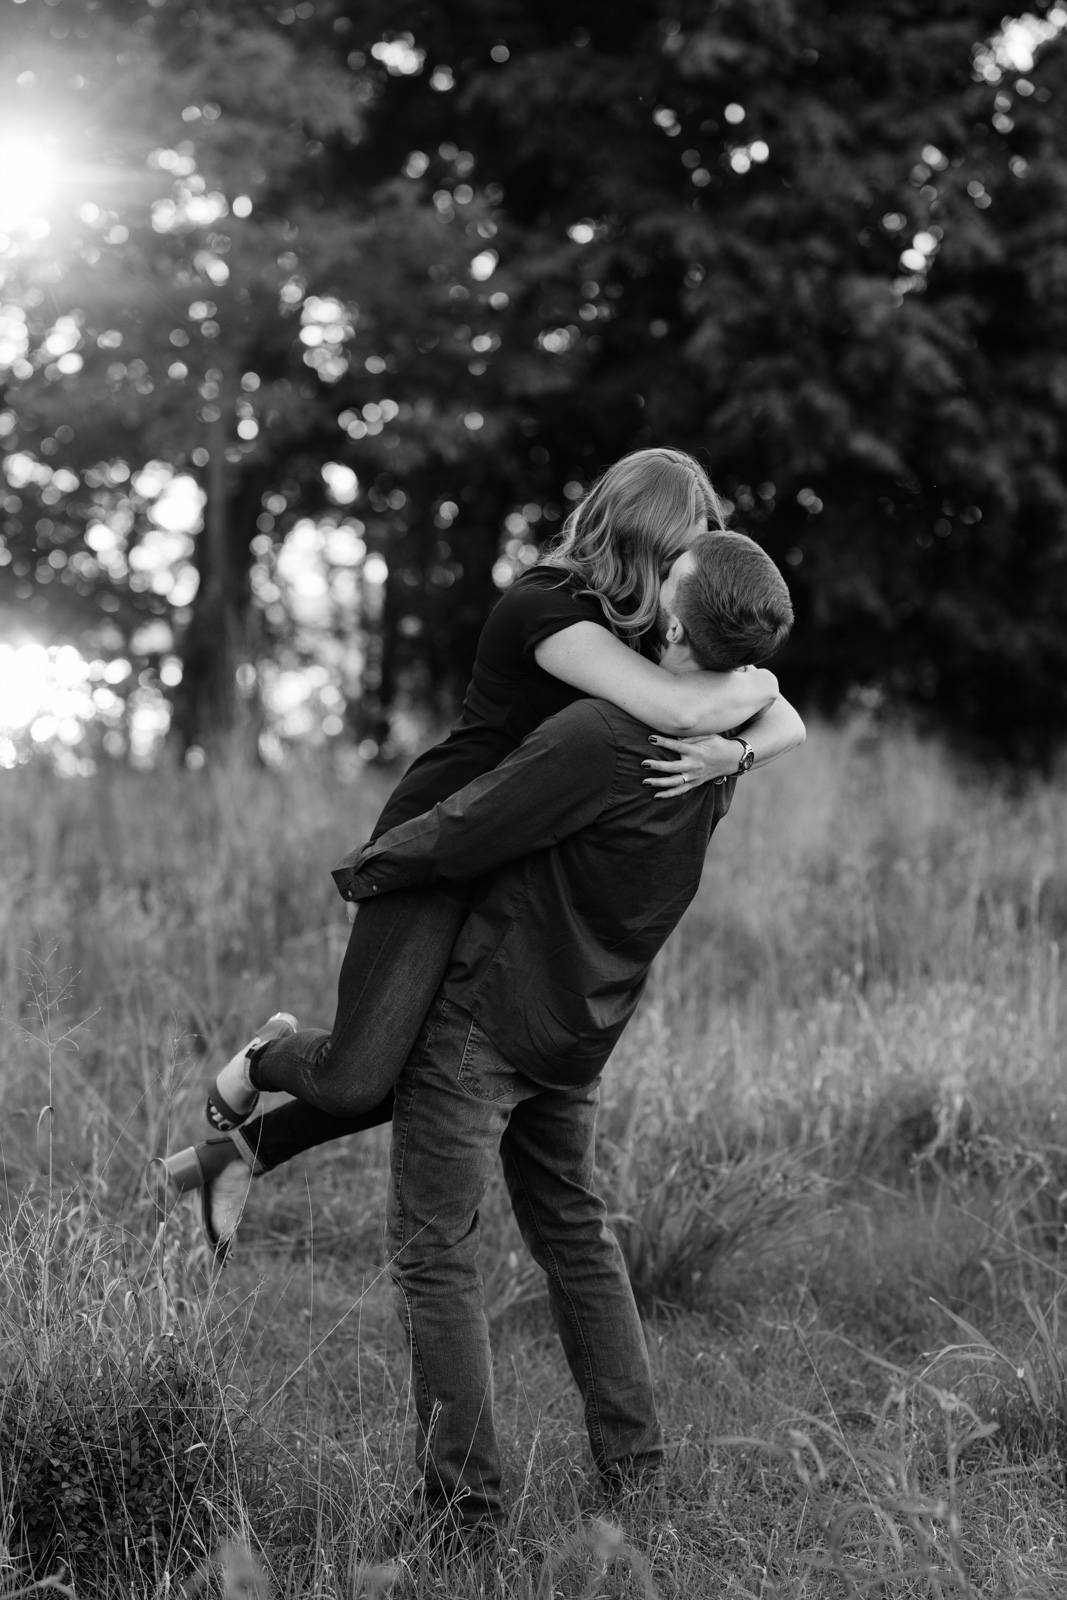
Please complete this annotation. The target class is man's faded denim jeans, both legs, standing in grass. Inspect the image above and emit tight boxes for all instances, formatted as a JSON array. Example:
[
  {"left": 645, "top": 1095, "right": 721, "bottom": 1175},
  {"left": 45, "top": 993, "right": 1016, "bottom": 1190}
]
[{"left": 389, "top": 1000, "right": 662, "bottom": 1523}]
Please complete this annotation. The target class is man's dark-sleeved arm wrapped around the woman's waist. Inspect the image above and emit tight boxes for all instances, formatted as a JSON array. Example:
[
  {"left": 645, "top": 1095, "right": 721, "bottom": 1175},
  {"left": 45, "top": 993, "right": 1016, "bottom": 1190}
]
[{"left": 333, "top": 701, "right": 616, "bottom": 899}]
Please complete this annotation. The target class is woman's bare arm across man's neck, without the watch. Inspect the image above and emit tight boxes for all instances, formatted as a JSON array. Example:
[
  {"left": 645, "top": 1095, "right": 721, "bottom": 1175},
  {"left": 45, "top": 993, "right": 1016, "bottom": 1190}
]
[{"left": 534, "top": 622, "right": 777, "bottom": 736}]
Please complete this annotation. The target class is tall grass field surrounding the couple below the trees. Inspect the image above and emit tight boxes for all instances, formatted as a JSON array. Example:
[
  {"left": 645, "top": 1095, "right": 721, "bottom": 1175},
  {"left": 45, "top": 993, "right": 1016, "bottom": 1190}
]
[{"left": 0, "top": 726, "right": 1067, "bottom": 1600}]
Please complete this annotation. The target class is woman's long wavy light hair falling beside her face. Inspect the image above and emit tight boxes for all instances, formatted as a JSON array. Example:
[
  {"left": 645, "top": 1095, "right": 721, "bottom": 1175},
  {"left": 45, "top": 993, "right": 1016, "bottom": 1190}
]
[{"left": 541, "top": 450, "right": 726, "bottom": 648}]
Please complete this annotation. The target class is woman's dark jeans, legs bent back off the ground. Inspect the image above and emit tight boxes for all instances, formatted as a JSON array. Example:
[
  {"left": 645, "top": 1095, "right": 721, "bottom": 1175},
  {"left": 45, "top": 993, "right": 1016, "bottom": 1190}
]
[{"left": 237, "top": 885, "right": 467, "bottom": 1173}]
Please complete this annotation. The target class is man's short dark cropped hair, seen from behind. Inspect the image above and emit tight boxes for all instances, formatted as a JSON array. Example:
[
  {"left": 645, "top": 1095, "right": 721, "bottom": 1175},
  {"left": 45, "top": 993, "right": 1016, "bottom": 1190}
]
[{"left": 673, "top": 533, "right": 793, "bottom": 672}]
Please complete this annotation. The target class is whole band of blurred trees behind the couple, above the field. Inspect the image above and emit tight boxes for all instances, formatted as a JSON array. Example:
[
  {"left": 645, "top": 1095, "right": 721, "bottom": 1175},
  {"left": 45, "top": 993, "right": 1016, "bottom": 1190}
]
[{"left": 0, "top": 0, "right": 1067, "bottom": 752}]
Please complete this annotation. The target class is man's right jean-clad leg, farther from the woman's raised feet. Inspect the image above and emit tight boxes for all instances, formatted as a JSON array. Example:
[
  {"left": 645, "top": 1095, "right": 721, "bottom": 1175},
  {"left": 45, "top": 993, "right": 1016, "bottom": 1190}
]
[{"left": 501, "top": 1083, "right": 664, "bottom": 1488}]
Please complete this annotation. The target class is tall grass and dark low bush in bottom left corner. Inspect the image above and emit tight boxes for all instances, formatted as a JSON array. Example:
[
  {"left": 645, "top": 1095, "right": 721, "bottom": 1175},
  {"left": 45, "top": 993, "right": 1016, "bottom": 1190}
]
[{"left": 0, "top": 1190, "right": 266, "bottom": 1597}]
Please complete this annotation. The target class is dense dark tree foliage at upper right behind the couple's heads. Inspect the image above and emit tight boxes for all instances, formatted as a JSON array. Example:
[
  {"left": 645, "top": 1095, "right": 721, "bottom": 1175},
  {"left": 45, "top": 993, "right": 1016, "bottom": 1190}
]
[{"left": 399, "top": 0, "right": 1067, "bottom": 750}]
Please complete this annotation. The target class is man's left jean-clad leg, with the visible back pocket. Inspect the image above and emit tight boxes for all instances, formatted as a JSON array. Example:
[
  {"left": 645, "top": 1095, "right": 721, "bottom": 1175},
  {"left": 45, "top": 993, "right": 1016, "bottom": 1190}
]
[{"left": 389, "top": 1000, "right": 537, "bottom": 1525}]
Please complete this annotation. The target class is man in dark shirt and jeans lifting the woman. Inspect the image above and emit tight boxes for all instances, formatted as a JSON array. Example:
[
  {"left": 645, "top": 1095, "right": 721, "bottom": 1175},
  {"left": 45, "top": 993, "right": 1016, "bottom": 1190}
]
[{"left": 334, "top": 534, "right": 803, "bottom": 1528}]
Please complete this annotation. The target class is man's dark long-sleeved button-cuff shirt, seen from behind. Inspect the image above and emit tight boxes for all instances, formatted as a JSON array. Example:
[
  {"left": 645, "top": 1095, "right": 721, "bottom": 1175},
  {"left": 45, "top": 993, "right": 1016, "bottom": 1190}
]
[{"left": 334, "top": 699, "right": 734, "bottom": 1088}]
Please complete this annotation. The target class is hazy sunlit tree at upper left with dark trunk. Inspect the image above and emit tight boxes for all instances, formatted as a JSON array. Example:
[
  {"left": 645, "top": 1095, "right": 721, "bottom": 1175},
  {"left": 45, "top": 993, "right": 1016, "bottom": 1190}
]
[{"left": 6, "top": 6, "right": 358, "bottom": 742}]
